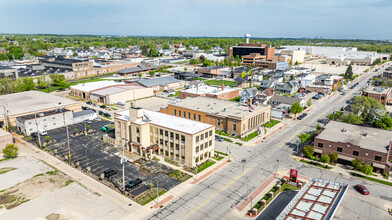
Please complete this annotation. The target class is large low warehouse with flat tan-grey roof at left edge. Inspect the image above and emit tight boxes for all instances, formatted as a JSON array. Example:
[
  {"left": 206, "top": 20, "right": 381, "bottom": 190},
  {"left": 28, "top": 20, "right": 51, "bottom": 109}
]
[{"left": 0, "top": 91, "right": 81, "bottom": 128}]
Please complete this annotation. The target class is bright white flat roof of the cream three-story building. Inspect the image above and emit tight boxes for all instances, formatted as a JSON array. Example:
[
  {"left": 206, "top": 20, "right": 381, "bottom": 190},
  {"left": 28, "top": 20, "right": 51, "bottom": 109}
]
[{"left": 116, "top": 109, "right": 214, "bottom": 134}]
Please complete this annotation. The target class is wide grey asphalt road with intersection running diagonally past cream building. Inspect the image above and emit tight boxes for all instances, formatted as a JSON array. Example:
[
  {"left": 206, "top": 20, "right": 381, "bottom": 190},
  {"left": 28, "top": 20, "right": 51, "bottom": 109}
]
[{"left": 150, "top": 62, "right": 392, "bottom": 219}]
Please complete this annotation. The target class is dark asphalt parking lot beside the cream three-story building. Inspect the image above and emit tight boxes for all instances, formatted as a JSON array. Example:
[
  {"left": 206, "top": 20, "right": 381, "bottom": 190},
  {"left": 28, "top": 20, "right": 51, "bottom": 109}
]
[{"left": 33, "top": 121, "right": 181, "bottom": 196}]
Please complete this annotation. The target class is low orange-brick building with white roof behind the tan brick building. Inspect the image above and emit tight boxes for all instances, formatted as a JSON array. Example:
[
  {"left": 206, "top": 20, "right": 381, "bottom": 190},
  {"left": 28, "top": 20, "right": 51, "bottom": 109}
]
[{"left": 179, "top": 83, "right": 240, "bottom": 100}]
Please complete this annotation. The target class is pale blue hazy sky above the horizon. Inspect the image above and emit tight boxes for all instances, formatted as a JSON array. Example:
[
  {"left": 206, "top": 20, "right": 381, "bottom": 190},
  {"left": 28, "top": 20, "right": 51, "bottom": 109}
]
[{"left": 0, "top": 0, "right": 392, "bottom": 40}]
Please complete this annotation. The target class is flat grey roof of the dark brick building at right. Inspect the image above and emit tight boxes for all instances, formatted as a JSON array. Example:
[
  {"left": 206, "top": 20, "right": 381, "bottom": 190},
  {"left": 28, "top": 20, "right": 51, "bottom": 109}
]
[{"left": 316, "top": 121, "right": 392, "bottom": 153}]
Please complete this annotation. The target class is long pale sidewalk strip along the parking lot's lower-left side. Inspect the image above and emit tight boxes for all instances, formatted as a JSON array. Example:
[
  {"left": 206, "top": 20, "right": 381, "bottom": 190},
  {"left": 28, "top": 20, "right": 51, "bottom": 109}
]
[{"left": 13, "top": 135, "right": 150, "bottom": 219}]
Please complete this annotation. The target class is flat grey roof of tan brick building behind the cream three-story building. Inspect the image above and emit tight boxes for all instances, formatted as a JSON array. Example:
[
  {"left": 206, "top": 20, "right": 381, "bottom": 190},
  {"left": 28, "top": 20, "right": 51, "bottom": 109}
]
[{"left": 168, "top": 96, "right": 270, "bottom": 118}]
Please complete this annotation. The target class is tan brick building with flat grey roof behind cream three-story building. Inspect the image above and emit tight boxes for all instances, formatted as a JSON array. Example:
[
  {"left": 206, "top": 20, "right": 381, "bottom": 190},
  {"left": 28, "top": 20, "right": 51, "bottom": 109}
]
[{"left": 161, "top": 96, "right": 271, "bottom": 138}]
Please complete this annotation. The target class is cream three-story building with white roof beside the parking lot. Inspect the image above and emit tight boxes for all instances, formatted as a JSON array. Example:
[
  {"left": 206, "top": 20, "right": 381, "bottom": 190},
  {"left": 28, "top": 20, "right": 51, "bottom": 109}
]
[{"left": 114, "top": 107, "right": 215, "bottom": 167}]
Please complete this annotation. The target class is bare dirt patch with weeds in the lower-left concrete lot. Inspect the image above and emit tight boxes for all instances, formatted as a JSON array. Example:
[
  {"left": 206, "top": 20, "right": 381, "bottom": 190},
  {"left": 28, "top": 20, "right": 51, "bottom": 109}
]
[{"left": 0, "top": 171, "right": 70, "bottom": 209}]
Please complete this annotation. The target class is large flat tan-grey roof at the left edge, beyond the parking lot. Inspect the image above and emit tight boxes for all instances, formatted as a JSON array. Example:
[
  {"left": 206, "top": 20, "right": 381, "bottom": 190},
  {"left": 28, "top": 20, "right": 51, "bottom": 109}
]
[{"left": 0, "top": 91, "right": 79, "bottom": 117}]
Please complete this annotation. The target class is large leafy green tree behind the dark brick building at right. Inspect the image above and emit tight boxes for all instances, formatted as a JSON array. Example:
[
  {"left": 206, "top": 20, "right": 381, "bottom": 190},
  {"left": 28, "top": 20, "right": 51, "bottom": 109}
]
[{"left": 351, "top": 96, "right": 387, "bottom": 124}]
